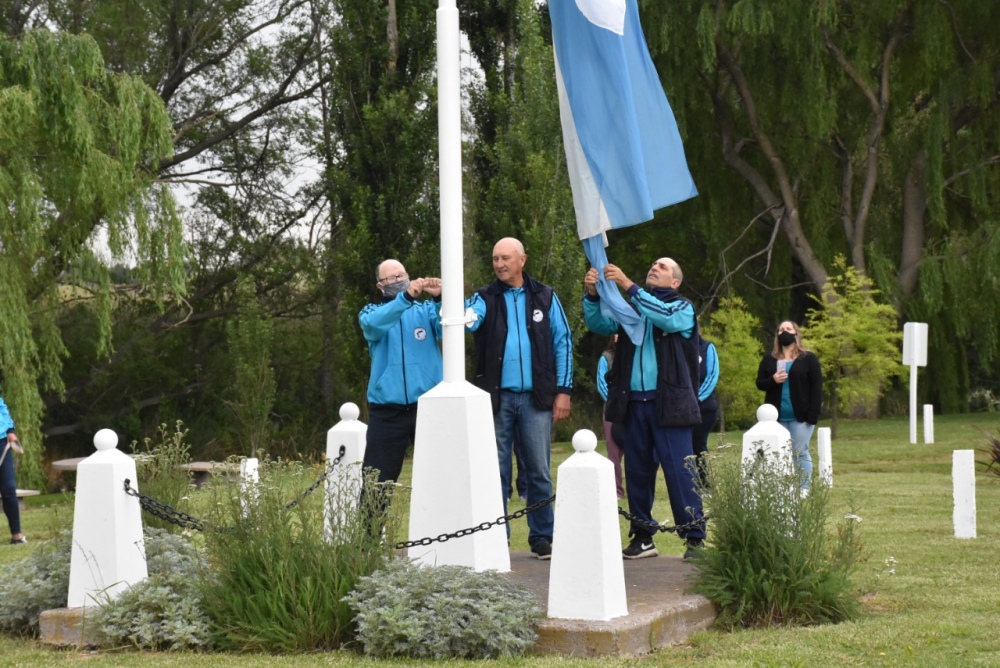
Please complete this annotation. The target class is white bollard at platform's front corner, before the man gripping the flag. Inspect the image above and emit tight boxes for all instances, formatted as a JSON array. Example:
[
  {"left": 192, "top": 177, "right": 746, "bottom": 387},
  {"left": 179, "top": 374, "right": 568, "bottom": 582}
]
[{"left": 548, "top": 429, "right": 628, "bottom": 621}]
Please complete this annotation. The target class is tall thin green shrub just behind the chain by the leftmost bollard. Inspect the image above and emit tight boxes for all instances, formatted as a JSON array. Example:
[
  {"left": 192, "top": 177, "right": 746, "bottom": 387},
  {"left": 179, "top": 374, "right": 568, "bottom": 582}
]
[{"left": 132, "top": 420, "right": 191, "bottom": 532}]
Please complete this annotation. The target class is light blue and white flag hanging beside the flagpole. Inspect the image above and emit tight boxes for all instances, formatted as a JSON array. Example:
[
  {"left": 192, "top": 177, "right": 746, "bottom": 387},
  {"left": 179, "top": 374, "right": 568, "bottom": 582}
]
[{"left": 549, "top": 0, "right": 698, "bottom": 343}]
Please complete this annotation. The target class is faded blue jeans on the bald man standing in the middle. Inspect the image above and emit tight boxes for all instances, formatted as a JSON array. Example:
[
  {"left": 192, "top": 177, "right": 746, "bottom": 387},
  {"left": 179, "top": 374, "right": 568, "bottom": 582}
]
[{"left": 493, "top": 390, "right": 554, "bottom": 547}]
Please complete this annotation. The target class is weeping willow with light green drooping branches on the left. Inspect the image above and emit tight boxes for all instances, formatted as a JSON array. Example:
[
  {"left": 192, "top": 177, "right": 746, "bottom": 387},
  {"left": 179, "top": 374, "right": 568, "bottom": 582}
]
[{"left": 0, "top": 31, "right": 184, "bottom": 485}]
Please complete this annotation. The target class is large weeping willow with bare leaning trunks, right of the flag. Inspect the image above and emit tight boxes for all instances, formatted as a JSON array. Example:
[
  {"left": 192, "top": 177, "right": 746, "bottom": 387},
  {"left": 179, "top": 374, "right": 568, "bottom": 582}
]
[{"left": 640, "top": 0, "right": 1000, "bottom": 410}]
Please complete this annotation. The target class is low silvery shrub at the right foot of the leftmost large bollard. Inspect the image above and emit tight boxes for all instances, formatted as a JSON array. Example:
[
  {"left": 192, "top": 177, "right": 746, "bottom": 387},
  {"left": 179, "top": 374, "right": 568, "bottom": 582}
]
[{"left": 96, "top": 529, "right": 211, "bottom": 650}]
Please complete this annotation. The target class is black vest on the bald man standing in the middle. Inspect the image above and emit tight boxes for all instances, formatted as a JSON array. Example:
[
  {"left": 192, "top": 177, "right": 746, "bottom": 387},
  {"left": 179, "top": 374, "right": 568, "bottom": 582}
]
[{"left": 472, "top": 274, "right": 556, "bottom": 414}]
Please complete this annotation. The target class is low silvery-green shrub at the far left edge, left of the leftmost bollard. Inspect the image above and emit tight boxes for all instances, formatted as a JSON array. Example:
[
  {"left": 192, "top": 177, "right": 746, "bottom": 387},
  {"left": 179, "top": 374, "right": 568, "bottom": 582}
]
[{"left": 0, "top": 531, "right": 72, "bottom": 636}]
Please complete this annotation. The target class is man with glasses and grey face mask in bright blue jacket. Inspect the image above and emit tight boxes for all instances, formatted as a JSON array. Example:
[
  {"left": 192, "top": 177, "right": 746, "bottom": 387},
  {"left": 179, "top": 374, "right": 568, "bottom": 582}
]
[{"left": 358, "top": 259, "right": 442, "bottom": 520}]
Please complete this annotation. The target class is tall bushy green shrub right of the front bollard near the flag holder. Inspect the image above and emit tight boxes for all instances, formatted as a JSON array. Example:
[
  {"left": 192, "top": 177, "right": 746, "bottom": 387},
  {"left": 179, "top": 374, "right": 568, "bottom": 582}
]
[{"left": 695, "top": 450, "right": 862, "bottom": 628}]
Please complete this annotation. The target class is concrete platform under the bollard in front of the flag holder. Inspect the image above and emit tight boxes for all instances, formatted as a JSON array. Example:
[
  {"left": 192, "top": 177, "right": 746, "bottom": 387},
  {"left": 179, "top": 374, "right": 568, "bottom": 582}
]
[{"left": 510, "top": 552, "right": 716, "bottom": 657}]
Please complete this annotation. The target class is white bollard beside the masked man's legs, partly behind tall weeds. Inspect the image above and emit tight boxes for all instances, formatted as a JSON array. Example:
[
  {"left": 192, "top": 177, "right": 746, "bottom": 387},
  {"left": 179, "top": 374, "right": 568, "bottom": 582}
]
[{"left": 323, "top": 402, "right": 368, "bottom": 542}]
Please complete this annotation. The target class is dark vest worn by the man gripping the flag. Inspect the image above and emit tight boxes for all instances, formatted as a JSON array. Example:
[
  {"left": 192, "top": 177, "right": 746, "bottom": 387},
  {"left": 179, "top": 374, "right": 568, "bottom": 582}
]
[{"left": 605, "top": 296, "right": 701, "bottom": 427}]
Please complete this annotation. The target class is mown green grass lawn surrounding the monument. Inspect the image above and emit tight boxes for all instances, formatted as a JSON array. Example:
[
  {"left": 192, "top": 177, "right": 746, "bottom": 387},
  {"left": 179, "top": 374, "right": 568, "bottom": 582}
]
[{"left": 0, "top": 413, "right": 1000, "bottom": 668}]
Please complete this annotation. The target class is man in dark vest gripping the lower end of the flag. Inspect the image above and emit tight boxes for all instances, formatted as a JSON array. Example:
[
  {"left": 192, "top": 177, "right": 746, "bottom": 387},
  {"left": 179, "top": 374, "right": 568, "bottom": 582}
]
[{"left": 583, "top": 257, "right": 705, "bottom": 559}]
